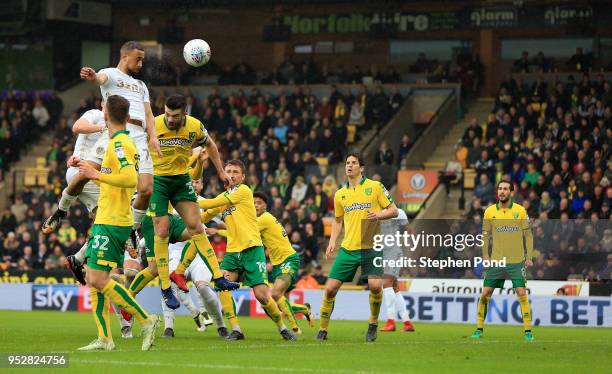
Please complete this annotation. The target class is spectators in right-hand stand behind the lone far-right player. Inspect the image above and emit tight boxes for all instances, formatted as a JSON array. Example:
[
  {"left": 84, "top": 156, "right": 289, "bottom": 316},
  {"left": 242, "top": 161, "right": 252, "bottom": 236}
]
[{"left": 440, "top": 74, "right": 612, "bottom": 280}]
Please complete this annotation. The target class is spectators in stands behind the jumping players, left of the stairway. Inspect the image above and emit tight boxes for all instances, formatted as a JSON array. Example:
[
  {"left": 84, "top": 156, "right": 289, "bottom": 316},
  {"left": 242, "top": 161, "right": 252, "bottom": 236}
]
[{"left": 0, "top": 82, "right": 403, "bottom": 287}]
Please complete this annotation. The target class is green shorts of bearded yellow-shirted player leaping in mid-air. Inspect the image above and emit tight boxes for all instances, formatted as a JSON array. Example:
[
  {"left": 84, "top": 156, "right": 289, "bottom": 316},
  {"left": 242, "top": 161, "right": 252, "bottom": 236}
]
[{"left": 149, "top": 174, "right": 198, "bottom": 217}]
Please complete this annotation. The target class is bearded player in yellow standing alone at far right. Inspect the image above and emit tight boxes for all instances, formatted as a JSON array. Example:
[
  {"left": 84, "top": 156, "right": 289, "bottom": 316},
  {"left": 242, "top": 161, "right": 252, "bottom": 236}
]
[{"left": 472, "top": 180, "right": 534, "bottom": 341}]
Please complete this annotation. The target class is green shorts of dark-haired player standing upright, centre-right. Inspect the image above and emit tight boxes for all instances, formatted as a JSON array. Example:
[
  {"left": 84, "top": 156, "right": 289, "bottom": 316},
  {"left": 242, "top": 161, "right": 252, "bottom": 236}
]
[{"left": 329, "top": 247, "right": 384, "bottom": 282}]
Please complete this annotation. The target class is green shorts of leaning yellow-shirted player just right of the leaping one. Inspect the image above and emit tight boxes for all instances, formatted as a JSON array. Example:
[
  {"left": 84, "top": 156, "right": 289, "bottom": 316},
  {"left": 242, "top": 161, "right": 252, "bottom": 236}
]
[{"left": 219, "top": 246, "right": 268, "bottom": 287}]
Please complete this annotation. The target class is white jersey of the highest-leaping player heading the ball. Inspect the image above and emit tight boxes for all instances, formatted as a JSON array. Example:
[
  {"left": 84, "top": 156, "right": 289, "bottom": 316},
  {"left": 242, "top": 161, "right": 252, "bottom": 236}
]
[{"left": 98, "top": 68, "right": 150, "bottom": 127}]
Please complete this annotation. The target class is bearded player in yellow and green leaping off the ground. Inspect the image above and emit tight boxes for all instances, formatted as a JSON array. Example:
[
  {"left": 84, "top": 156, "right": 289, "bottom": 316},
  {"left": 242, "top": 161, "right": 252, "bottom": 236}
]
[{"left": 149, "top": 94, "right": 239, "bottom": 309}]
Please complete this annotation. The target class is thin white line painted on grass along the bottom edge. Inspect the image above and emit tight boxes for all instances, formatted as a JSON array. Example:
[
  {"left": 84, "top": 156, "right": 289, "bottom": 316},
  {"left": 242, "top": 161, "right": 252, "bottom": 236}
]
[{"left": 70, "top": 359, "right": 394, "bottom": 374}]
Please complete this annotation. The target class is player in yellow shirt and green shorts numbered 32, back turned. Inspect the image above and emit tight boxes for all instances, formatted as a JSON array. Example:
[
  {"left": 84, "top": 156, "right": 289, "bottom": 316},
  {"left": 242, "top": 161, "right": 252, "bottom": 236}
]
[{"left": 79, "top": 95, "right": 159, "bottom": 351}]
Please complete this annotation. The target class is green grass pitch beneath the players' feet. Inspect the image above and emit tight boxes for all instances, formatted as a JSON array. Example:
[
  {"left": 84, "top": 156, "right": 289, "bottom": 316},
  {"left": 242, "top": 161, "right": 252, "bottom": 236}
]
[{"left": 0, "top": 311, "right": 612, "bottom": 374}]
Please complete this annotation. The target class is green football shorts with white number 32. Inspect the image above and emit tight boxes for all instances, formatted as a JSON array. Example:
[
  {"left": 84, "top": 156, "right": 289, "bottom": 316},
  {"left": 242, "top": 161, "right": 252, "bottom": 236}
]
[{"left": 85, "top": 224, "right": 132, "bottom": 271}]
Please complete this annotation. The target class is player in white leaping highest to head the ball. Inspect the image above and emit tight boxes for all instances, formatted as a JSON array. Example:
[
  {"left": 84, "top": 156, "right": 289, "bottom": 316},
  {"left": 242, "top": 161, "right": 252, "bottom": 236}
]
[{"left": 42, "top": 41, "right": 161, "bottom": 253}]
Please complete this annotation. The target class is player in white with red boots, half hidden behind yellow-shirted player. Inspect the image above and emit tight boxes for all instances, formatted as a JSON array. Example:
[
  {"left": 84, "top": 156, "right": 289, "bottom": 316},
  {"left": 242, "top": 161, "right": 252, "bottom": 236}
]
[{"left": 380, "top": 209, "right": 414, "bottom": 332}]
